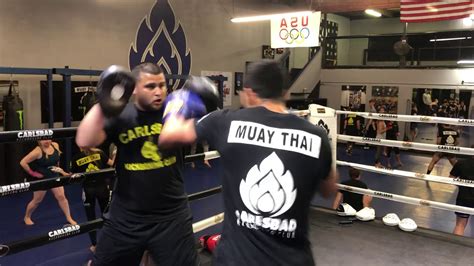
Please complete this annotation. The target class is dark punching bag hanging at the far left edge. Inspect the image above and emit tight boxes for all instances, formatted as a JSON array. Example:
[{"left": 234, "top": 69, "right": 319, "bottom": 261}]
[{"left": 3, "top": 83, "right": 25, "bottom": 184}]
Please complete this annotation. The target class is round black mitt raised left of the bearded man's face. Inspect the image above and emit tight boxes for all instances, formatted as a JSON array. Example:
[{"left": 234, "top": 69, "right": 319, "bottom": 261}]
[{"left": 97, "top": 65, "right": 135, "bottom": 117}]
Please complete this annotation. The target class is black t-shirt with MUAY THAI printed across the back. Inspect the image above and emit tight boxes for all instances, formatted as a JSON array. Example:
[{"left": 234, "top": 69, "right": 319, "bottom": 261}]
[{"left": 196, "top": 107, "right": 332, "bottom": 266}]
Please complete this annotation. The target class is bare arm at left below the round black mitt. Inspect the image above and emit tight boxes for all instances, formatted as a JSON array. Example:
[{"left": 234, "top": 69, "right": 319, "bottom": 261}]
[{"left": 76, "top": 104, "right": 107, "bottom": 148}]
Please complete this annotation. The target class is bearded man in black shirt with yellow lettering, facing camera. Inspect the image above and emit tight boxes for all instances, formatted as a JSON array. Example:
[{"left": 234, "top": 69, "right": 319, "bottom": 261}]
[{"left": 76, "top": 63, "right": 197, "bottom": 266}]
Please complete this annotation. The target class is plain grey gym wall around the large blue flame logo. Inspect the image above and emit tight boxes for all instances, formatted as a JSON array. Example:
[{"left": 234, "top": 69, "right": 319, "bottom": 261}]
[{"left": 0, "top": 0, "right": 270, "bottom": 129}]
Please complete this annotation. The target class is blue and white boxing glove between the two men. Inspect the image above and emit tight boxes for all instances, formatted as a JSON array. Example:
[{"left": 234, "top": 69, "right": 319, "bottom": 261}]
[{"left": 163, "top": 89, "right": 207, "bottom": 123}]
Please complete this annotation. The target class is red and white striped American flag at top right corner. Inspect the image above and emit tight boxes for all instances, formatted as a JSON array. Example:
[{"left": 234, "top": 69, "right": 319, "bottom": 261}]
[{"left": 400, "top": 0, "right": 474, "bottom": 22}]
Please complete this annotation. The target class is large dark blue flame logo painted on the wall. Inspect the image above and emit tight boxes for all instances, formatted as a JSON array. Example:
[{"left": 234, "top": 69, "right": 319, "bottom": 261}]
[{"left": 128, "top": 0, "right": 191, "bottom": 90}]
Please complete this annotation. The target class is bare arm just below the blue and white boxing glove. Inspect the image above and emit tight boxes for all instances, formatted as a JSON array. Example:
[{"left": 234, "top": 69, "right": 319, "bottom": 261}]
[{"left": 158, "top": 115, "right": 197, "bottom": 148}]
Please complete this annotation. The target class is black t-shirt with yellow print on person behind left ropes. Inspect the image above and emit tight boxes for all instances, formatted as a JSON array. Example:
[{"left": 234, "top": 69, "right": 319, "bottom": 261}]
[{"left": 71, "top": 149, "right": 109, "bottom": 185}]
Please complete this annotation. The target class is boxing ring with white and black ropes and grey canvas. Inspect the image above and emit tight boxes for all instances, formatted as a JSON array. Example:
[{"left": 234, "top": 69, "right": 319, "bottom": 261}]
[{"left": 0, "top": 107, "right": 474, "bottom": 265}]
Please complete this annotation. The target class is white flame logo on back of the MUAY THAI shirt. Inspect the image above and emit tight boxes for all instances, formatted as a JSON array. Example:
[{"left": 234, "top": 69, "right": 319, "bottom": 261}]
[{"left": 240, "top": 152, "right": 296, "bottom": 217}]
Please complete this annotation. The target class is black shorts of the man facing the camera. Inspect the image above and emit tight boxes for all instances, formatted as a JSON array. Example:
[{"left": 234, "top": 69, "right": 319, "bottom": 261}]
[{"left": 92, "top": 211, "right": 198, "bottom": 266}]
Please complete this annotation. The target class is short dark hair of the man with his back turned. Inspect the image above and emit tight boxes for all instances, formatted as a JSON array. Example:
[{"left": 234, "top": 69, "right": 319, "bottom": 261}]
[{"left": 244, "top": 60, "right": 288, "bottom": 99}]
